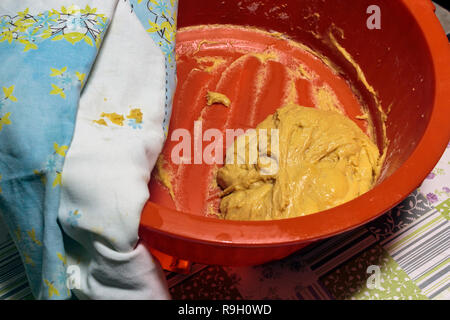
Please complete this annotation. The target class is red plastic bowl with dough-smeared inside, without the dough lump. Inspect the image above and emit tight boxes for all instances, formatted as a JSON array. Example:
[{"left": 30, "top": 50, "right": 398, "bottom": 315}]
[{"left": 140, "top": 0, "right": 450, "bottom": 265}]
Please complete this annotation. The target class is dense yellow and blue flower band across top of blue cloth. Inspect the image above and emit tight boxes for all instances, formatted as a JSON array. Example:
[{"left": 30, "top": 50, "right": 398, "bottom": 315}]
[{"left": 0, "top": 5, "right": 108, "bottom": 52}]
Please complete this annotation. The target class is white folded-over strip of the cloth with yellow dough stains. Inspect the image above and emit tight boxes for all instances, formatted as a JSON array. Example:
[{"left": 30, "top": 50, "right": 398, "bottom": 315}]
[{"left": 59, "top": 1, "right": 176, "bottom": 299}]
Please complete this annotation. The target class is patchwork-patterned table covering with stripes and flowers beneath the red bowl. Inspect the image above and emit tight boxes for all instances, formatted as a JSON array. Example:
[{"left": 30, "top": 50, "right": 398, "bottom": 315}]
[{"left": 0, "top": 5, "right": 450, "bottom": 300}]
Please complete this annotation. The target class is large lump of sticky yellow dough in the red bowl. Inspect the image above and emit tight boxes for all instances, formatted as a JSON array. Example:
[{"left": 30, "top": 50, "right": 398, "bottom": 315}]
[{"left": 217, "top": 105, "right": 382, "bottom": 220}]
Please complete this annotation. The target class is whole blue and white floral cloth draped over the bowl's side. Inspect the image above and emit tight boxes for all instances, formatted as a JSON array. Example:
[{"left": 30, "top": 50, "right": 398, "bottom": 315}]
[{"left": 0, "top": 0, "right": 176, "bottom": 299}]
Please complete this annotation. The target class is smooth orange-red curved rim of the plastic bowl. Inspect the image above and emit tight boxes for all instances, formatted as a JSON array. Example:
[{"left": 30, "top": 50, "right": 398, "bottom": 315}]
[{"left": 141, "top": 0, "right": 450, "bottom": 247}]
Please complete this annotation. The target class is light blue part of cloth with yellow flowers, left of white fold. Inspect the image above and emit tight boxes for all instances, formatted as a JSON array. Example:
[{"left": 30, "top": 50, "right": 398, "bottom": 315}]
[{"left": 0, "top": 0, "right": 116, "bottom": 299}]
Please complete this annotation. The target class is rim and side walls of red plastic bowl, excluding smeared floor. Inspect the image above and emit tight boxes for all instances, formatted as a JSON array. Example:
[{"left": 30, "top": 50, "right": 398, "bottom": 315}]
[{"left": 140, "top": 0, "right": 450, "bottom": 266}]
